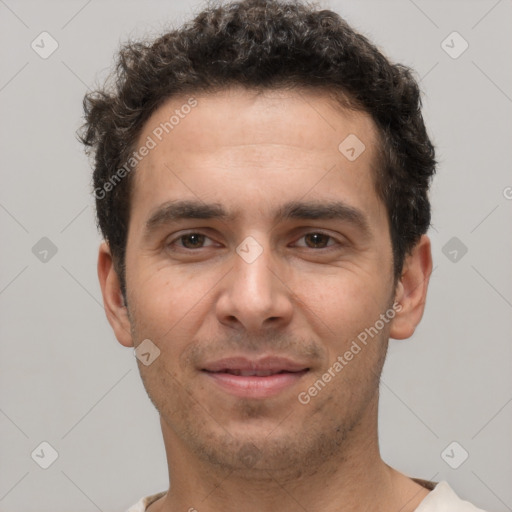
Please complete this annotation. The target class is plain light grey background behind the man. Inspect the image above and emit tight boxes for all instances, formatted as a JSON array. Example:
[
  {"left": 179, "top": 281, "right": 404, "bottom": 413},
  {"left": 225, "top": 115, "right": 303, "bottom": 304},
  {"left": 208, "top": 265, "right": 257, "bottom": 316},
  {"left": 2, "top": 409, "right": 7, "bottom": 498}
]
[{"left": 0, "top": 0, "right": 512, "bottom": 512}]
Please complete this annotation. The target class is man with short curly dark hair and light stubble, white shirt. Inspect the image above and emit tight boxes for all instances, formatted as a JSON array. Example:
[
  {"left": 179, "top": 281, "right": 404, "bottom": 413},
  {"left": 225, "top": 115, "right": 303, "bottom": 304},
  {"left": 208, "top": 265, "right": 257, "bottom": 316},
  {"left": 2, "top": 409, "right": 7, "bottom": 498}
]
[{"left": 81, "top": 0, "right": 488, "bottom": 512}]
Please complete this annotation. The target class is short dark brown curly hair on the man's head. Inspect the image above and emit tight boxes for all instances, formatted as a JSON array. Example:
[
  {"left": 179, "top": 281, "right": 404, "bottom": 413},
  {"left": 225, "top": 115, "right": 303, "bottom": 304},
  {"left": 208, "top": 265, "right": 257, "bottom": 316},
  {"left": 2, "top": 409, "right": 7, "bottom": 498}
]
[{"left": 78, "top": 0, "right": 436, "bottom": 301}]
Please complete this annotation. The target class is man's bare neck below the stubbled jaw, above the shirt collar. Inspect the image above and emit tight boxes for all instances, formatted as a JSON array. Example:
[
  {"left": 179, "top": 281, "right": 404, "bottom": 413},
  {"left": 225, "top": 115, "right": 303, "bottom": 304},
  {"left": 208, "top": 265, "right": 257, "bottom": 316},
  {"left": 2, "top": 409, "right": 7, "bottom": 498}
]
[{"left": 148, "top": 403, "right": 428, "bottom": 512}]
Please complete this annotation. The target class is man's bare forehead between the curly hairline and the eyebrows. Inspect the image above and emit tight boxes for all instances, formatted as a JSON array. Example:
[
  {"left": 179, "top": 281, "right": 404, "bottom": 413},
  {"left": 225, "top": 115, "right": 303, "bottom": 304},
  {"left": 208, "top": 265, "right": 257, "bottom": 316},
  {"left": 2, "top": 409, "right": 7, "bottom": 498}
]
[{"left": 128, "top": 88, "right": 384, "bottom": 228}]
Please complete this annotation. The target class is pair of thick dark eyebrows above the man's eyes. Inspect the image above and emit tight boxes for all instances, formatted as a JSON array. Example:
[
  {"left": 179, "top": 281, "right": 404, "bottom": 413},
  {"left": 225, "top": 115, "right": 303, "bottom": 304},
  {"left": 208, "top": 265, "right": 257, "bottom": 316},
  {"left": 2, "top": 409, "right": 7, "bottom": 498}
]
[{"left": 144, "top": 199, "right": 371, "bottom": 238}]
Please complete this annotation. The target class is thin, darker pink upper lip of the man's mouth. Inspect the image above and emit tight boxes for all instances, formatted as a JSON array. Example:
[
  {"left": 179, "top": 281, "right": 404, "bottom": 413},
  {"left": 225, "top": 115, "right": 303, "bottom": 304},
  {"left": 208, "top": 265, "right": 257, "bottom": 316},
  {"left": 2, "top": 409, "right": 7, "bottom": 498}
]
[{"left": 202, "top": 356, "right": 309, "bottom": 373}]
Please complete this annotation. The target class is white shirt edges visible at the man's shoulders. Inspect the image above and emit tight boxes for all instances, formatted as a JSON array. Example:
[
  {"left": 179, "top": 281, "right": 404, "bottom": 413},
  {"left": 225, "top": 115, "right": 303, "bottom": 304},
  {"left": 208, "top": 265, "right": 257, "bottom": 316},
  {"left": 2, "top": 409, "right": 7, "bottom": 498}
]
[{"left": 126, "top": 481, "right": 485, "bottom": 512}]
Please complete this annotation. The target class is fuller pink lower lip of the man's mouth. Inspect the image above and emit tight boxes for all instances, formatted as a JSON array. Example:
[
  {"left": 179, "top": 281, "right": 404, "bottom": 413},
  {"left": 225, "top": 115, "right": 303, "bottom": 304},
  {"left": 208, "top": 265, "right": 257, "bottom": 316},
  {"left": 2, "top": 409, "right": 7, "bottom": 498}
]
[{"left": 204, "top": 370, "right": 308, "bottom": 398}]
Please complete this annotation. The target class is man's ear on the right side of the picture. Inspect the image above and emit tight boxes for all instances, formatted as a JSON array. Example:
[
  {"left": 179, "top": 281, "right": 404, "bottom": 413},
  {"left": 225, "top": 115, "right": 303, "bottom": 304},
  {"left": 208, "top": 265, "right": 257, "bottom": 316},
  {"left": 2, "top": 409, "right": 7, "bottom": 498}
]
[{"left": 389, "top": 235, "right": 432, "bottom": 340}]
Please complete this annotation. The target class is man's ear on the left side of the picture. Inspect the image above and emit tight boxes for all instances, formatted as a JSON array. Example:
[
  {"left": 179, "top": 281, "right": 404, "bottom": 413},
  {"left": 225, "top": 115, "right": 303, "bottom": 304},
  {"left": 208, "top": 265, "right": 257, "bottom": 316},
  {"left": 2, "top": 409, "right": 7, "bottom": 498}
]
[{"left": 98, "top": 241, "right": 133, "bottom": 347}]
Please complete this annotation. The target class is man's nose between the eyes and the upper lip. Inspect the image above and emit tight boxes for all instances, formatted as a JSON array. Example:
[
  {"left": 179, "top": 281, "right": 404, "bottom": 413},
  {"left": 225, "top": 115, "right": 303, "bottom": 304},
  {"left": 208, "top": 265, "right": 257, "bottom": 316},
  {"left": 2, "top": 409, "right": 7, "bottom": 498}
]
[{"left": 216, "top": 239, "right": 293, "bottom": 333}]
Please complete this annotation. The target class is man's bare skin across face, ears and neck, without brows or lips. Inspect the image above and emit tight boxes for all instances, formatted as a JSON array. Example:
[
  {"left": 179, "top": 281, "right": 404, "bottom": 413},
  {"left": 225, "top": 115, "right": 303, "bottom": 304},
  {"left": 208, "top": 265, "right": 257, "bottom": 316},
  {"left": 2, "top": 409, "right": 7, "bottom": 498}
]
[{"left": 98, "top": 88, "right": 432, "bottom": 512}]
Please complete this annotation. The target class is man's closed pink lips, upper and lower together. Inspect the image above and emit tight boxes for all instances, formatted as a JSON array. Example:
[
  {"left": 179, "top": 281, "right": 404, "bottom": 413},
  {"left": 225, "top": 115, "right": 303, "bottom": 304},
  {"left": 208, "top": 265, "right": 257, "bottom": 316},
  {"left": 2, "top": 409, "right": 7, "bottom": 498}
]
[{"left": 202, "top": 356, "right": 309, "bottom": 398}]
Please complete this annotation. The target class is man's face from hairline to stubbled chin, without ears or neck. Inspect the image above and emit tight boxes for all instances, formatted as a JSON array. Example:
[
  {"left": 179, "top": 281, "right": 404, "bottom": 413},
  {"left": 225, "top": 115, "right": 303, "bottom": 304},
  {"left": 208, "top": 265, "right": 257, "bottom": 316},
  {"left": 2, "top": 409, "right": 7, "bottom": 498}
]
[{"left": 122, "top": 89, "right": 394, "bottom": 469}]
